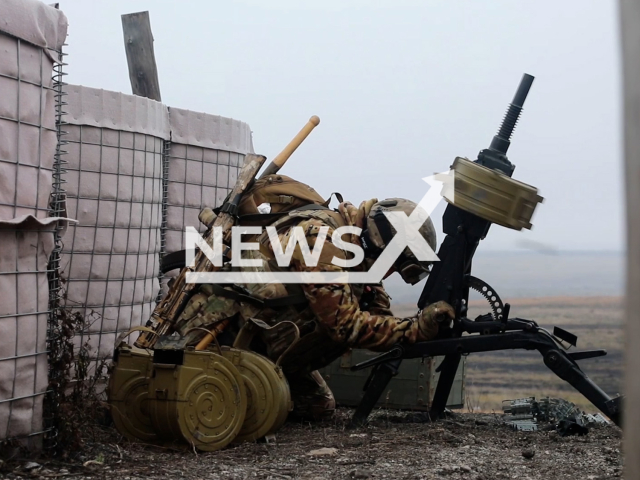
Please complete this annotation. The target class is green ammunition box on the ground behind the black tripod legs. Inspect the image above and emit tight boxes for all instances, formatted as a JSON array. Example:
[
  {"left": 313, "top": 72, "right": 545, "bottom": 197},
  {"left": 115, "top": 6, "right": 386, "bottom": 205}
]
[{"left": 320, "top": 350, "right": 466, "bottom": 411}]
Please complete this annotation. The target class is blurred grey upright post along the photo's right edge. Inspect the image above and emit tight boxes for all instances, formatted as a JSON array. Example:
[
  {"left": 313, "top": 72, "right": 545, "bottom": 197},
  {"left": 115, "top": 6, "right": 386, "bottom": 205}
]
[{"left": 619, "top": 0, "right": 640, "bottom": 479}]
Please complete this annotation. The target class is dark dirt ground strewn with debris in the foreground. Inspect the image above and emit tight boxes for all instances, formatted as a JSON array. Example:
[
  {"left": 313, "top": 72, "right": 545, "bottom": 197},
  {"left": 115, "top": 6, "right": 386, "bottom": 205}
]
[{"left": 0, "top": 409, "right": 622, "bottom": 480}]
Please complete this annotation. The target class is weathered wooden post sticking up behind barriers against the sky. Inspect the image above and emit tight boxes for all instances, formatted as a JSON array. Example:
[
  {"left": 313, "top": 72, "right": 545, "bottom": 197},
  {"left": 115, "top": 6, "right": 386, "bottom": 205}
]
[{"left": 122, "top": 12, "right": 161, "bottom": 102}]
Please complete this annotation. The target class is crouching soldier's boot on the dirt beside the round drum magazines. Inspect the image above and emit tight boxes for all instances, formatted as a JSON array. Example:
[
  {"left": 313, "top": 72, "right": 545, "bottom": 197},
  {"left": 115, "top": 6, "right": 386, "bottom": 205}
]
[{"left": 287, "top": 370, "right": 336, "bottom": 421}]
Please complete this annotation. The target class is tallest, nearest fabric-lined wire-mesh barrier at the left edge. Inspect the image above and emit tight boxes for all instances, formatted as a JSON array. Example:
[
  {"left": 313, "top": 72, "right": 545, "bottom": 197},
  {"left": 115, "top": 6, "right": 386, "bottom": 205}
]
[{"left": 0, "top": 0, "right": 67, "bottom": 447}]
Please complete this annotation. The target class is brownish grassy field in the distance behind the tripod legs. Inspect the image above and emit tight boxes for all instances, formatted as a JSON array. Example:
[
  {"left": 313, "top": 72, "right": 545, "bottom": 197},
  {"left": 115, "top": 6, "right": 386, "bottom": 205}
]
[{"left": 394, "top": 297, "right": 623, "bottom": 412}]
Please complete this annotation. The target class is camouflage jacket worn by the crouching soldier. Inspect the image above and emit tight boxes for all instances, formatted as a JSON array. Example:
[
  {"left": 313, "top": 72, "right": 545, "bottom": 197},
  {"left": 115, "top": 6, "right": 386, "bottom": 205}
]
[{"left": 176, "top": 204, "right": 436, "bottom": 372}]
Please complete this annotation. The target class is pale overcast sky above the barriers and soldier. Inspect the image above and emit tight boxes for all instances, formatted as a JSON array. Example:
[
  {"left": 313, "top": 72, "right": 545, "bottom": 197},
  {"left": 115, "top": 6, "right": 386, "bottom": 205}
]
[{"left": 60, "top": 0, "right": 624, "bottom": 250}]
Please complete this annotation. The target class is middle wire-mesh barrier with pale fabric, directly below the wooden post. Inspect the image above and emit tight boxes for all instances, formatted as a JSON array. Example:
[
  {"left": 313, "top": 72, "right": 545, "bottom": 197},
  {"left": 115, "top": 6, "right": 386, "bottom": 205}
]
[{"left": 61, "top": 86, "right": 168, "bottom": 359}]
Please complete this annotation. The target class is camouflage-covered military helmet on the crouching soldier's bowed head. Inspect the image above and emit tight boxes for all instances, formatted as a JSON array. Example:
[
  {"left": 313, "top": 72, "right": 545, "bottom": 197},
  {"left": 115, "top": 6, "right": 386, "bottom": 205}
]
[{"left": 361, "top": 198, "right": 436, "bottom": 285}]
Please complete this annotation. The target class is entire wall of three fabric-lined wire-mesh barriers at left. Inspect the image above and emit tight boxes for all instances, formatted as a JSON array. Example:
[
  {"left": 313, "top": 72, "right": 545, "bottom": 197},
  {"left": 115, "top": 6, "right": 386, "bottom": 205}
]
[{"left": 0, "top": 0, "right": 253, "bottom": 443}]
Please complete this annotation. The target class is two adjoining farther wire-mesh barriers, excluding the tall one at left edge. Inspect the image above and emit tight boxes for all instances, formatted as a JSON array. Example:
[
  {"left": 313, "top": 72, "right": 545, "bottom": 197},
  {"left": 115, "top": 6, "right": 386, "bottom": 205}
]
[{"left": 61, "top": 90, "right": 253, "bottom": 359}]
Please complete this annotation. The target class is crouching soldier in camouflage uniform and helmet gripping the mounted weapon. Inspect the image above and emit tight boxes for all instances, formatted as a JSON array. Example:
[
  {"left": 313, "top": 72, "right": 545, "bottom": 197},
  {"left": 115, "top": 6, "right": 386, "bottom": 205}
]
[{"left": 176, "top": 199, "right": 455, "bottom": 419}]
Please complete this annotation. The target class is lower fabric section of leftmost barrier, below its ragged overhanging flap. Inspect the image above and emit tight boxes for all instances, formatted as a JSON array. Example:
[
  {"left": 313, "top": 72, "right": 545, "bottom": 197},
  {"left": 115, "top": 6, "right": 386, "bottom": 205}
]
[{"left": 0, "top": 215, "right": 68, "bottom": 439}]
